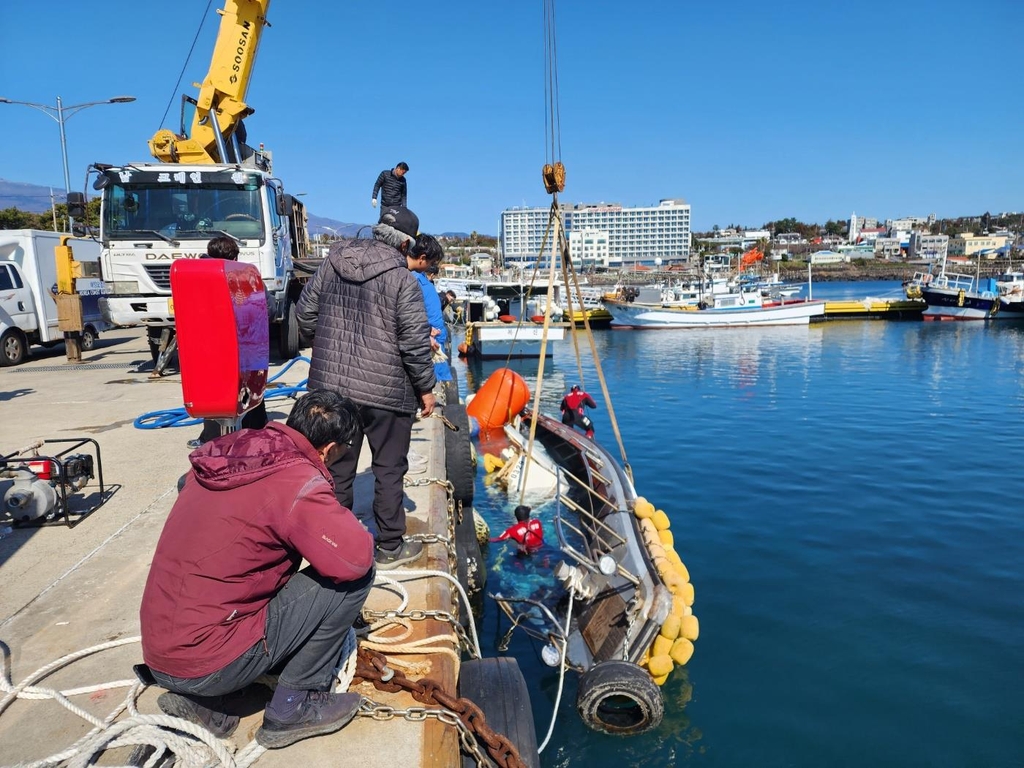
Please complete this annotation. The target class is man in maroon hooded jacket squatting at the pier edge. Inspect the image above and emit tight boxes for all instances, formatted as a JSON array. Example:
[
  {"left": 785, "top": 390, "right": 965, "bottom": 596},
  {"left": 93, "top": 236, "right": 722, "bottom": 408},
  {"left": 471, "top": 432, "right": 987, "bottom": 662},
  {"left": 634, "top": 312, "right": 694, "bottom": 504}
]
[{"left": 140, "top": 391, "right": 374, "bottom": 749}]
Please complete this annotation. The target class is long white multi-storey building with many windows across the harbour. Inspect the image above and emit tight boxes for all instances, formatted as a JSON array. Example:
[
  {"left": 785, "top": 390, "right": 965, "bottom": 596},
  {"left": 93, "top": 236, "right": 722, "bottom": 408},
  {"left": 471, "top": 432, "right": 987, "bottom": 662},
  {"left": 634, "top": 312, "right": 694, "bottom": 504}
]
[{"left": 499, "top": 199, "right": 690, "bottom": 268}]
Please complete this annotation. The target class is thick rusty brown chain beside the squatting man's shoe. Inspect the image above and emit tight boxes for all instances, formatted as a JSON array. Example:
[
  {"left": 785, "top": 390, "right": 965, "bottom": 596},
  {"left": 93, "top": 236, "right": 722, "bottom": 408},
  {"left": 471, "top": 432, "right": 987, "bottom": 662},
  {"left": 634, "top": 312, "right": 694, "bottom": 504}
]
[{"left": 353, "top": 647, "right": 526, "bottom": 768}]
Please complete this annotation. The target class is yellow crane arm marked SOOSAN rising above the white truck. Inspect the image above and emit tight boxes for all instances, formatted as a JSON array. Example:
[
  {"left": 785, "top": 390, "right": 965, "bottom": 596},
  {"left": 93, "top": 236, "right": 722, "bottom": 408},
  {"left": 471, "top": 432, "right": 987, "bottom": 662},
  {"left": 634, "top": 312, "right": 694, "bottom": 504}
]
[{"left": 150, "top": 0, "right": 270, "bottom": 164}]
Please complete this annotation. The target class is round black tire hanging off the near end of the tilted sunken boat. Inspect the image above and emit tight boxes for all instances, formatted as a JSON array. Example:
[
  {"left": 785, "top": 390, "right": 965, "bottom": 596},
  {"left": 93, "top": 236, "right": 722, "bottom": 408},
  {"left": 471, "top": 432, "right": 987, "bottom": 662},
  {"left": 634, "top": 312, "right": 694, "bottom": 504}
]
[{"left": 577, "top": 659, "right": 665, "bottom": 736}]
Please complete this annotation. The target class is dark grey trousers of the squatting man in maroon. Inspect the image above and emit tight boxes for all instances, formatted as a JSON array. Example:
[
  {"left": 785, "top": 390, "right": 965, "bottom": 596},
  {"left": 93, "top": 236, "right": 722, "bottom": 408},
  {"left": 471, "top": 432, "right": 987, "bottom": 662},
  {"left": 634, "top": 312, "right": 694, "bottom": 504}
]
[{"left": 153, "top": 567, "right": 374, "bottom": 696}]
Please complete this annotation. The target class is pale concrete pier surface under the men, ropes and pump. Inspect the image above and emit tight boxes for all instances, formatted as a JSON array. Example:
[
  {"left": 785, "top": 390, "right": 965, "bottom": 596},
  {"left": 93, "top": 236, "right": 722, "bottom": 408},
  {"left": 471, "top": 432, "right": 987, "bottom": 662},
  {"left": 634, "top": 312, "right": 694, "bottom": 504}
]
[{"left": 0, "top": 329, "right": 460, "bottom": 768}]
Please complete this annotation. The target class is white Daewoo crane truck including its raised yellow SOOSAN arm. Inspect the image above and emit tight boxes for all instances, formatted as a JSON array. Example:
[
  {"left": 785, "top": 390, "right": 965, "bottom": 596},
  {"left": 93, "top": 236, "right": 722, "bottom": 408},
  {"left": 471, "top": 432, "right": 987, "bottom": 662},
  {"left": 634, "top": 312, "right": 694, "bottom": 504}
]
[{"left": 68, "top": 0, "right": 316, "bottom": 371}]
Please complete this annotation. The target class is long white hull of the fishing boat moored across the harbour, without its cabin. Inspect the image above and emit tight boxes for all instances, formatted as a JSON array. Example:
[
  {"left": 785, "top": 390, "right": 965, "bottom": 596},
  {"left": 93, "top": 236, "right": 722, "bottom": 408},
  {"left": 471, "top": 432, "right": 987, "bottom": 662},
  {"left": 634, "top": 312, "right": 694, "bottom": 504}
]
[{"left": 605, "top": 299, "right": 825, "bottom": 329}]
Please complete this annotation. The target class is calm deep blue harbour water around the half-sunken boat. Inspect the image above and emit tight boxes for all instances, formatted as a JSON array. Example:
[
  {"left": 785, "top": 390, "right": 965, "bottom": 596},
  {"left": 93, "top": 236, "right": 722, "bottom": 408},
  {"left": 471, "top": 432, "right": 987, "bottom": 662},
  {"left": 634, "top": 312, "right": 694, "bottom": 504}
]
[{"left": 459, "top": 283, "right": 1024, "bottom": 768}]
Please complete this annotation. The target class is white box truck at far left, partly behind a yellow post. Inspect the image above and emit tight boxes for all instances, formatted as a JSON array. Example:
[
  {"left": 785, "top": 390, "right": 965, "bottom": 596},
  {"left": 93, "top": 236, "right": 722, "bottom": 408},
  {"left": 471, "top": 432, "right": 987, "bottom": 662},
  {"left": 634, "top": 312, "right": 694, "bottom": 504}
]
[{"left": 0, "top": 229, "right": 106, "bottom": 366}]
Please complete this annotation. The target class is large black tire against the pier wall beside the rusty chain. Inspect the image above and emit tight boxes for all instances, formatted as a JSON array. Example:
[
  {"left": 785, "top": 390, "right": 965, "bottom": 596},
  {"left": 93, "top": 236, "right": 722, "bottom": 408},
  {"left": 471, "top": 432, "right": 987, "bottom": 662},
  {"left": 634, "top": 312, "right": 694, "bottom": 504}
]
[{"left": 459, "top": 656, "right": 541, "bottom": 768}]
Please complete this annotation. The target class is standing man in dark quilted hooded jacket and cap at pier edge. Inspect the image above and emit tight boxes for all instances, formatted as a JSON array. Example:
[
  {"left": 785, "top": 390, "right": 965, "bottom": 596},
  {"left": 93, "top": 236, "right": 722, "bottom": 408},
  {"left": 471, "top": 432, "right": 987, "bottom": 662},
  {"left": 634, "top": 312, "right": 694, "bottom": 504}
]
[{"left": 295, "top": 208, "right": 436, "bottom": 569}]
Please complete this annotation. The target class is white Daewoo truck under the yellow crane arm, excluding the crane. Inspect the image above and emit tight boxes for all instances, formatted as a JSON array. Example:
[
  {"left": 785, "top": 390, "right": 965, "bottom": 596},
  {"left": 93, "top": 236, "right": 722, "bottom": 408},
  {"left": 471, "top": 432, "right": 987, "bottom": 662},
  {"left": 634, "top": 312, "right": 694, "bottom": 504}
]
[{"left": 69, "top": 163, "right": 311, "bottom": 360}]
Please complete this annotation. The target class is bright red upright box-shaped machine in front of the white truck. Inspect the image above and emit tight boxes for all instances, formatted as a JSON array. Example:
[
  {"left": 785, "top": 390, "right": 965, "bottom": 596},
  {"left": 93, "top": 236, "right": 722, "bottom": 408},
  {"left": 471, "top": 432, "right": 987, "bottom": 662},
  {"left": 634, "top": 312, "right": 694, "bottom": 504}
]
[{"left": 171, "top": 259, "right": 270, "bottom": 420}]
